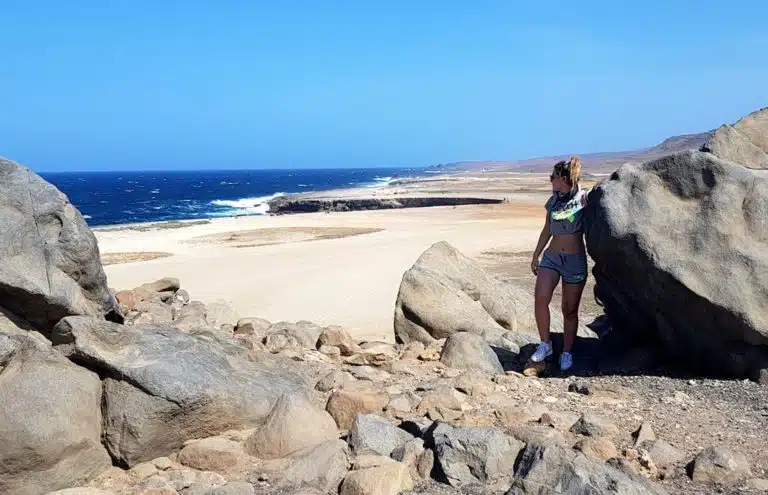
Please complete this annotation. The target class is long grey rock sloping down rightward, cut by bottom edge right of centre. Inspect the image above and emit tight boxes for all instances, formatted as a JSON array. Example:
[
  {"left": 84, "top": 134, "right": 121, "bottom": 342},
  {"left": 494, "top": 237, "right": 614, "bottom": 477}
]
[{"left": 507, "top": 445, "right": 666, "bottom": 495}]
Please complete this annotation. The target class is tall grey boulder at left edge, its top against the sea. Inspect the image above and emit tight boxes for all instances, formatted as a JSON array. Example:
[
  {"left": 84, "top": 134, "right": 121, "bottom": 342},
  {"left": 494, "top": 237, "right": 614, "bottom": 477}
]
[{"left": 0, "top": 158, "right": 122, "bottom": 334}]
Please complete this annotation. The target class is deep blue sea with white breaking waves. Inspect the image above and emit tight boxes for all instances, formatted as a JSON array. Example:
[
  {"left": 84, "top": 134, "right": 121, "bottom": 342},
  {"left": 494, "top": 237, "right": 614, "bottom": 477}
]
[{"left": 40, "top": 168, "right": 421, "bottom": 226}]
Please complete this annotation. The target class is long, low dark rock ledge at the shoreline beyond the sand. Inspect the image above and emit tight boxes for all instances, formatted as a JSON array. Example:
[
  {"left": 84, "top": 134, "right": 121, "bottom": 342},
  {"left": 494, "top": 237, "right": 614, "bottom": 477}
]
[{"left": 268, "top": 196, "right": 502, "bottom": 214}]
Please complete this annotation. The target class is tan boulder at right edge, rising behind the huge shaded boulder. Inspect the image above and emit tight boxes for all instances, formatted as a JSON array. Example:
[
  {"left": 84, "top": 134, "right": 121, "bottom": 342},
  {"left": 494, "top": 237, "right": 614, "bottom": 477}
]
[{"left": 702, "top": 108, "right": 768, "bottom": 169}]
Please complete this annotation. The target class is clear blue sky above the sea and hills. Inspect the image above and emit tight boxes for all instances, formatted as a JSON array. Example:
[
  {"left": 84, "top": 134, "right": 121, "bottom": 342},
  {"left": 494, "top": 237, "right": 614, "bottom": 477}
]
[{"left": 0, "top": 0, "right": 768, "bottom": 171}]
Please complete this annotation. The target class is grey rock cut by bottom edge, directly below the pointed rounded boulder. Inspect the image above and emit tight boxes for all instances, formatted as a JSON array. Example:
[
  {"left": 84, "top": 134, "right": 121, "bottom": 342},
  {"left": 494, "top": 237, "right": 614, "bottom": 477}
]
[{"left": 282, "top": 440, "right": 349, "bottom": 493}]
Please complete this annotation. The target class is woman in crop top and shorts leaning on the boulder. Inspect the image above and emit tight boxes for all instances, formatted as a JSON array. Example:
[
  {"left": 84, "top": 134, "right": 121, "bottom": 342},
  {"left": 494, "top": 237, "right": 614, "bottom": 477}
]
[{"left": 531, "top": 156, "right": 587, "bottom": 371}]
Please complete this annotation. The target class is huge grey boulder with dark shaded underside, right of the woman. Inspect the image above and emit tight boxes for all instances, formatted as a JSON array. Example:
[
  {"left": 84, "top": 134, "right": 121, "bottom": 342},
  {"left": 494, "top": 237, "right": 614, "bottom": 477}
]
[{"left": 586, "top": 151, "right": 768, "bottom": 376}]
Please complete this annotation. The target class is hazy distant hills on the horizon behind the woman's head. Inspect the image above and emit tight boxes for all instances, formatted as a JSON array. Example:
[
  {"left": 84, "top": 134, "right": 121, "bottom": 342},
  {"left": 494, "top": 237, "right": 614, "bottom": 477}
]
[{"left": 427, "top": 131, "right": 714, "bottom": 173}]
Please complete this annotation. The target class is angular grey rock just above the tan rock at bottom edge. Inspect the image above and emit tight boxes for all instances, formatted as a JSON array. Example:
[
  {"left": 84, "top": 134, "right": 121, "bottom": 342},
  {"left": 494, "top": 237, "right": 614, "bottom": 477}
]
[{"left": 347, "top": 414, "right": 413, "bottom": 456}]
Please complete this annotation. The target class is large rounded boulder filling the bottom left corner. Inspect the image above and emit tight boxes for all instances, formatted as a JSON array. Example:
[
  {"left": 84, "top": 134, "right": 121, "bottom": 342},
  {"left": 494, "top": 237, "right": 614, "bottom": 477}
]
[{"left": 0, "top": 333, "right": 112, "bottom": 495}]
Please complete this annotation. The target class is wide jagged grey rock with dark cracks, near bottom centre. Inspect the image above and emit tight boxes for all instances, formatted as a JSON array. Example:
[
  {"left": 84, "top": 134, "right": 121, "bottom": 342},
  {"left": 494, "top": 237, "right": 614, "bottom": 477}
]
[{"left": 432, "top": 423, "right": 524, "bottom": 488}]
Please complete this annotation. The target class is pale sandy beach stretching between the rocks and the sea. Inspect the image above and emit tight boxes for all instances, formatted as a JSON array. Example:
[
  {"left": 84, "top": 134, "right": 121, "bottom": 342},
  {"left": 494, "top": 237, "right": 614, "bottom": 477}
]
[{"left": 96, "top": 176, "right": 548, "bottom": 340}]
